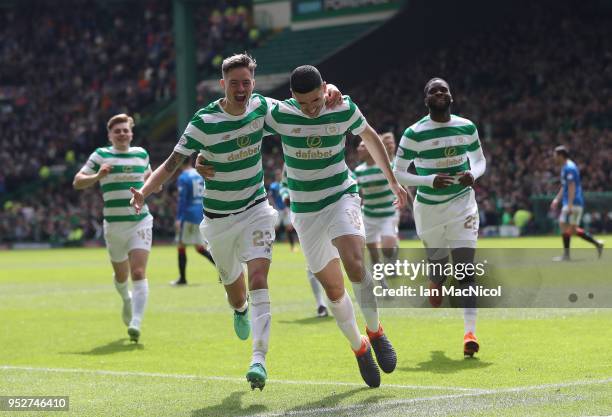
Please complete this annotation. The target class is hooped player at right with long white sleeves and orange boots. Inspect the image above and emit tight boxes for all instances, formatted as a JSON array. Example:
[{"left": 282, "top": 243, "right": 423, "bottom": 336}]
[{"left": 394, "top": 78, "right": 486, "bottom": 357}]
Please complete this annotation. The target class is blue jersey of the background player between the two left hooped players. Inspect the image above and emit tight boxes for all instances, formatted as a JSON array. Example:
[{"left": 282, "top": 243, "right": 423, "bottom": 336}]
[{"left": 176, "top": 168, "right": 205, "bottom": 224}]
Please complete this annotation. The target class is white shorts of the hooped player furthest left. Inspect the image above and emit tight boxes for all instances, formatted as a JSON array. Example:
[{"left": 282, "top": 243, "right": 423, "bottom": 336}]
[{"left": 104, "top": 215, "right": 153, "bottom": 262}]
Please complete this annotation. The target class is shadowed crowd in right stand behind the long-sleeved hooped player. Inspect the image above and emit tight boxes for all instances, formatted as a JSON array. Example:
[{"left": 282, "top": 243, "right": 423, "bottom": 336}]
[{"left": 348, "top": 4, "right": 612, "bottom": 230}]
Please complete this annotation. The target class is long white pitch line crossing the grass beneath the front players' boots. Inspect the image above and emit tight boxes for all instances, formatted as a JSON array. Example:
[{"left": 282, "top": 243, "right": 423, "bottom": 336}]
[{"left": 0, "top": 365, "right": 487, "bottom": 393}]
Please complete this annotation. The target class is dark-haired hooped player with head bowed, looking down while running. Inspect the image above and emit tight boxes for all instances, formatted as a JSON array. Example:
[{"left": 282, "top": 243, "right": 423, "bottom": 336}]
[{"left": 266, "top": 65, "right": 406, "bottom": 387}]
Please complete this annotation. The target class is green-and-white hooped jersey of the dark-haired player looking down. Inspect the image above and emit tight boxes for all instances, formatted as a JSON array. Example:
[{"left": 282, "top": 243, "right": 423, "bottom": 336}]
[{"left": 266, "top": 96, "right": 367, "bottom": 213}]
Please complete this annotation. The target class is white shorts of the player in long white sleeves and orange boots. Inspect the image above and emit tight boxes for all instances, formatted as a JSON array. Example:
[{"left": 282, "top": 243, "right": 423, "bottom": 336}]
[{"left": 414, "top": 190, "right": 480, "bottom": 259}]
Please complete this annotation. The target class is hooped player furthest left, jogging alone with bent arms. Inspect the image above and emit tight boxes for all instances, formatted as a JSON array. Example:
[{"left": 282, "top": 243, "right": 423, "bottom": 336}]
[{"left": 72, "top": 114, "right": 153, "bottom": 342}]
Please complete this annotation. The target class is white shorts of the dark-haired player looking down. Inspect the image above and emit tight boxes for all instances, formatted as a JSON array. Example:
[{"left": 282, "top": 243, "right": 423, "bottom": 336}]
[{"left": 291, "top": 194, "right": 365, "bottom": 273}]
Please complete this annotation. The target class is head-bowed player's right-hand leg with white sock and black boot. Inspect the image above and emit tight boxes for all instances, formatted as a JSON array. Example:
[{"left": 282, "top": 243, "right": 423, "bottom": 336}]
[{"left": 332, "top": 235, "right": 397, "bottom": 373}]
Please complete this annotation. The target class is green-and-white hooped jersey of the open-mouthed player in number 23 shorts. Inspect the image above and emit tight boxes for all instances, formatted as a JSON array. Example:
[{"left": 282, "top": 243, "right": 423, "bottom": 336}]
[{"left": 174, "top": 94, "right": 269, "bottom": 214}]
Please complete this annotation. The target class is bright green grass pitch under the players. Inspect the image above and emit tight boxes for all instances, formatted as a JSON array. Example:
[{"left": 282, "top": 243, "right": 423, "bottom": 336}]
[{"left": 0, "top": 237, "right": 612, "bottom": 416}]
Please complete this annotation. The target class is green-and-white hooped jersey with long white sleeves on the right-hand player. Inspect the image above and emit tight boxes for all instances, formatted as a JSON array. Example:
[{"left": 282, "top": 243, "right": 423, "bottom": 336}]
[{"left": 395, "top": 115, "right": 480, "bottom": 204}]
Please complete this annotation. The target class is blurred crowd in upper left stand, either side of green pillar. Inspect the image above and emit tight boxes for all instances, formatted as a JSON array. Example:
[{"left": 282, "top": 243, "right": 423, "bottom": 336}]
[{"left": 0, "top": 0, "right": 253, "bottom": 191}]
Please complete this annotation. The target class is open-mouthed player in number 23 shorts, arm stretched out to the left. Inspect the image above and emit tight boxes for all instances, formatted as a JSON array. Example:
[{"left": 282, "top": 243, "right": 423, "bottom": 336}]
[{"left": 131, "top": 54, "right": 339, "bottom": 390}]
